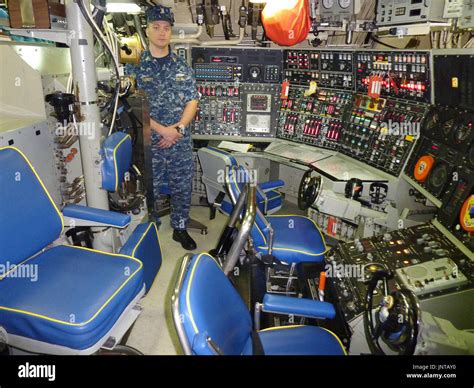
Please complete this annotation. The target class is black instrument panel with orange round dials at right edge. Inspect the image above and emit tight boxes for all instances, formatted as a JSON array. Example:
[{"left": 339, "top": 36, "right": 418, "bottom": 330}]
[{"left": 405, "top": 105, "right": 474, "bottom": 251}]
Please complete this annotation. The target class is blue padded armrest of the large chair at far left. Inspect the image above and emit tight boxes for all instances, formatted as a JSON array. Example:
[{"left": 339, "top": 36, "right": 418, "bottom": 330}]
[{"left": 63, "top": 205, "right": 131, "bottom": 228}]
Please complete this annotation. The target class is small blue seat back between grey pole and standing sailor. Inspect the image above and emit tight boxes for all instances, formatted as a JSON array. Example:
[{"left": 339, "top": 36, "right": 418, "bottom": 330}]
[{"left": 102, "top": 132, "right": 132, "bottom": 192}]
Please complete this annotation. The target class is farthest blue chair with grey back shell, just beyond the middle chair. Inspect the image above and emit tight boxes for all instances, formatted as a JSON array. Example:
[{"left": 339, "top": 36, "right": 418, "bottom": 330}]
[{"left": 198, "top": 147, "right": 285, "bottom": 216}]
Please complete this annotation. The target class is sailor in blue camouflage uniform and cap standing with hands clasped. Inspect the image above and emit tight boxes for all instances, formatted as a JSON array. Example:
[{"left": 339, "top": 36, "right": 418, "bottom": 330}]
[{"left": 135, "top": 5, "right": 199, "bottom": 250}]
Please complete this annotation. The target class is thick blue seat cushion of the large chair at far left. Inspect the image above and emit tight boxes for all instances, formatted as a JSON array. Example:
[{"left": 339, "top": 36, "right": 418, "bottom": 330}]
[{"left": 0, "top": 245, "right": 143, "bottom": 350}]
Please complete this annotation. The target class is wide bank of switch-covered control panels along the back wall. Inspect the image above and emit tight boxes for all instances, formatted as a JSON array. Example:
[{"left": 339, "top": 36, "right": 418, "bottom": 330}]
[{"left": 192, "top": 47, "right": 431, "bottom": 142}]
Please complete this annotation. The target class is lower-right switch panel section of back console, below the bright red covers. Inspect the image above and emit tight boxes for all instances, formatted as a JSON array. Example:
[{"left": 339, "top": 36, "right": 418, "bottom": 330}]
[{"left": 340, "top": 95, "right": 427, "bottom": 176}]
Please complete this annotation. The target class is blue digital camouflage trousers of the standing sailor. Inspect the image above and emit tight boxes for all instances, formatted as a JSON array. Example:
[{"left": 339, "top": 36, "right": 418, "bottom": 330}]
[{"left": 151, "top": 138, "right": 194, "bottom": 230}]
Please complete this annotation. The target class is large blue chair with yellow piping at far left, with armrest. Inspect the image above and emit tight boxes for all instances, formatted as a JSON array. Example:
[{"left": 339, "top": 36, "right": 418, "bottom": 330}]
[{"left": 0, "top": 147, "right": 151, "bottom": 354}]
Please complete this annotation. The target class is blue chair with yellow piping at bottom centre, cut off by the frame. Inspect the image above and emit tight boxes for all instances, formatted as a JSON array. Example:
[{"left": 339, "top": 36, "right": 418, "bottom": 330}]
[{"left": 172, "top": 253, "right": 346, "bottom": 355}]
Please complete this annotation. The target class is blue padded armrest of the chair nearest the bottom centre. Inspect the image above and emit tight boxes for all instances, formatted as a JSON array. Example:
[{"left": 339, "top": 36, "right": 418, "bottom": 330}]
[{"left": 262, "top": 294, "right": 336, "bottom": 319}]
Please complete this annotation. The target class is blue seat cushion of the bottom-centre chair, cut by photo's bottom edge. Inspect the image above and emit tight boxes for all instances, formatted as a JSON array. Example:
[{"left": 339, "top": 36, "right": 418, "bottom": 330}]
[{"left": 258, "top": 326, "right": 346, "bottom": 356}]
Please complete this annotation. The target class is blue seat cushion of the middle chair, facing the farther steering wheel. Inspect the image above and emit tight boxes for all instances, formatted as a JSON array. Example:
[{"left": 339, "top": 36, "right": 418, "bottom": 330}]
[{"left": 257, "top": 215, "right": 326, "bottom": 264}]
